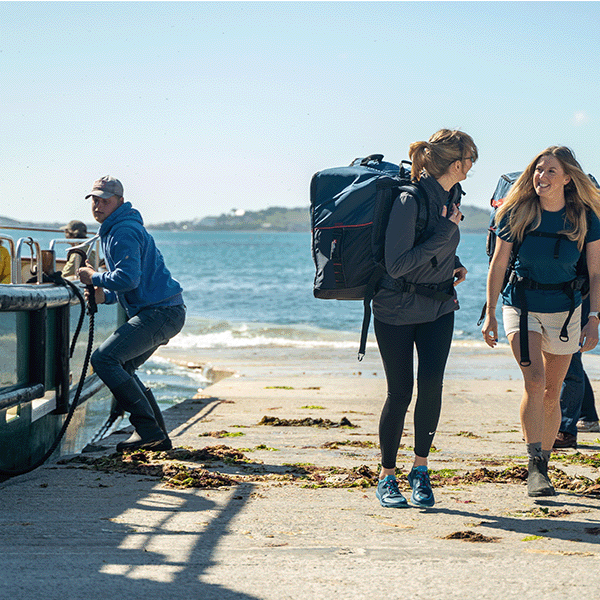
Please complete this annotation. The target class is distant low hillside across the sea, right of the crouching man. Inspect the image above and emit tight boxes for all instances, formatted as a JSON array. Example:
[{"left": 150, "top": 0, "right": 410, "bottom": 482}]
[{"left": 148, "top": 205, "right": 490, "bottom": 232}]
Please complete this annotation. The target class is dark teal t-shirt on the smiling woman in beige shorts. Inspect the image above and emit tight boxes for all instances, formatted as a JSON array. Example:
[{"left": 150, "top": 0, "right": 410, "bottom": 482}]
[{"left": 498, "top": 208, "right": 600, "bottom": 313}]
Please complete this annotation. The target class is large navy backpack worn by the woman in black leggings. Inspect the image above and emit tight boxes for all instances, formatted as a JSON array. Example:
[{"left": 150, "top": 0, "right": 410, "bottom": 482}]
[{"left": 310, "top": 154, "right": 429, "bottom": 360}]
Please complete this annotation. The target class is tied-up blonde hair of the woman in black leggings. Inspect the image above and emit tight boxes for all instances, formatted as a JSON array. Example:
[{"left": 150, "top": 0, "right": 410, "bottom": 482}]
[{"left": 408, "top": 129, "right": 479, "bottom": 181}]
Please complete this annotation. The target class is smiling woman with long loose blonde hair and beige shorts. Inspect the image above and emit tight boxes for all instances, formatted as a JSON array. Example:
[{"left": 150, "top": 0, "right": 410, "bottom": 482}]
[{"left": 482, "top": 146, "right": 600, "bottom": 497}]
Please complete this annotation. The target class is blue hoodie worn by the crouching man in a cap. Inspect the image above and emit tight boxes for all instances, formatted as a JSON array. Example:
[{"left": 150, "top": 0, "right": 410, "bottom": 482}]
[{"left": 92, "top": 202, "right": 183, "bottom": 318}]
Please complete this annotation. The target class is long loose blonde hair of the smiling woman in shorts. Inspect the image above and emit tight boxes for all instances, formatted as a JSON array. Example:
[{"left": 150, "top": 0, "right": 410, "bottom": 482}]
[{"left": 495, "top": 146, "right": 600, "bottom": 252}]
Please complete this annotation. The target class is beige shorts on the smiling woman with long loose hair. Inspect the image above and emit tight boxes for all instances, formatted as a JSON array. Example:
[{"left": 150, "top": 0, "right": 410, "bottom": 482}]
[{"left": 502, "top": 305, "right": 581, "bottom": 354}]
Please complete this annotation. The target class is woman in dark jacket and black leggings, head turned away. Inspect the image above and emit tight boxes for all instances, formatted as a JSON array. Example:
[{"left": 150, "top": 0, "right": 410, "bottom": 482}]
[{"left": 373, "top": 129, "right": 477, "bottom": 508}]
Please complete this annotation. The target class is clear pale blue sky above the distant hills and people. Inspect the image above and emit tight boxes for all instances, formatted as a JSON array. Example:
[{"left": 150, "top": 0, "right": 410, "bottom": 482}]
[{"left": 0, "top": 2, "right": 600, "bottom": 223}]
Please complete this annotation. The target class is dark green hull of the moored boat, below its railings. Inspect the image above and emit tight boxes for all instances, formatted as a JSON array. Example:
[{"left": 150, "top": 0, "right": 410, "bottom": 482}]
[{"left": 0, "top": 284, "right": 123, "bottom": 476}]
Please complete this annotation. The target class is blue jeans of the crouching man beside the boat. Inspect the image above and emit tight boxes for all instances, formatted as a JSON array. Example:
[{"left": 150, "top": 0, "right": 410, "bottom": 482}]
[{"left": 91, "top": 304, "right": 185, "bottom": 390}]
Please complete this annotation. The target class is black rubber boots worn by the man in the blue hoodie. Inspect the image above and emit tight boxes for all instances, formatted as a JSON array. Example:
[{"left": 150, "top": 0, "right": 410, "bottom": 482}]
[{"left": 111, "top": 378, "right": 171, "bottom": 452}]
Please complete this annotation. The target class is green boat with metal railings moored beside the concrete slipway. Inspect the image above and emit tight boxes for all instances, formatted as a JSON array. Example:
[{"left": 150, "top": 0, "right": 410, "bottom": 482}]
[{"left": 0, "top": 226, "right": 124, "bottom": 479}]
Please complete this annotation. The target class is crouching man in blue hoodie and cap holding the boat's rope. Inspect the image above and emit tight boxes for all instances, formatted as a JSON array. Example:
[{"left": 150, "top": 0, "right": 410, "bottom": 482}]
[{"left": 78, "top": 175, "right": 185, "bottom": 451}]
